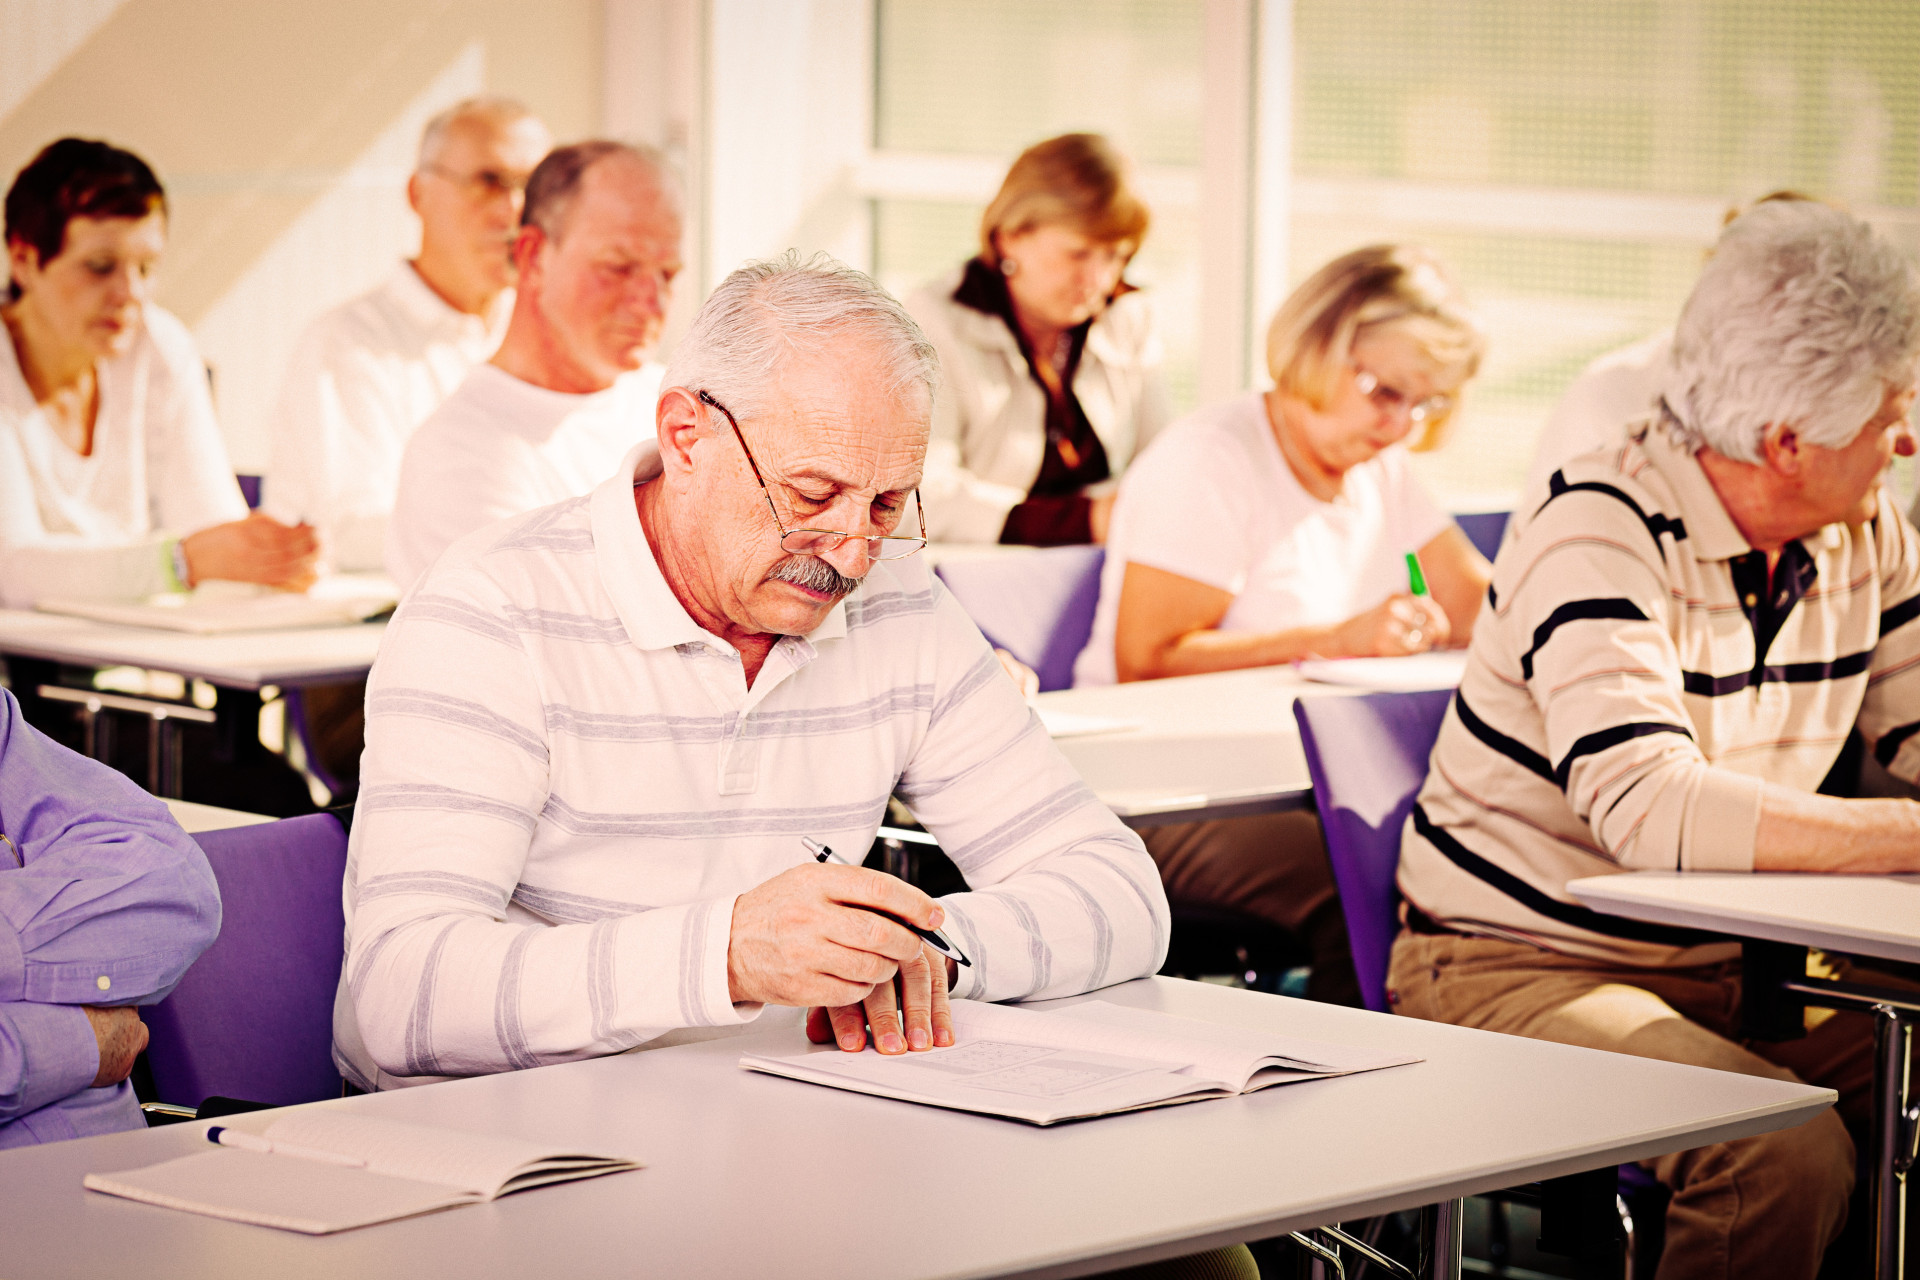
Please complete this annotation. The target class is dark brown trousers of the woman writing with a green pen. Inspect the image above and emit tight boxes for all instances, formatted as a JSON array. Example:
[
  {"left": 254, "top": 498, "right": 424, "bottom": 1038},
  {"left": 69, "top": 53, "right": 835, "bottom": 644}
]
[{"left": 1140, "top": 810, "right": 1361, "bottom": 1006}]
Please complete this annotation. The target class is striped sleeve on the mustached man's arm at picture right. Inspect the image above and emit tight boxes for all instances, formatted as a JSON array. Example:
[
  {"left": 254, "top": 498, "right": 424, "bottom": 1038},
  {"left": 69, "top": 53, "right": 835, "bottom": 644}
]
[{"left": 897, "top": 591, "right": 1169, "bottom": 1000}]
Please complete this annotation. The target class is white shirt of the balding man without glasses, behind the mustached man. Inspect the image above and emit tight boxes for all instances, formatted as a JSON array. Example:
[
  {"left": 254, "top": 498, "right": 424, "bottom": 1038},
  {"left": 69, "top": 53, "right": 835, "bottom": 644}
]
[{"left": 386, "top": 363, "right": 666, "bottom": 591}]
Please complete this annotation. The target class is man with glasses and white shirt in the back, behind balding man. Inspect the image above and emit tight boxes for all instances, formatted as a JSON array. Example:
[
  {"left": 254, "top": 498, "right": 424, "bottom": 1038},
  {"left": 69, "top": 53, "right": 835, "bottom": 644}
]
[{"left": 265, "top": 98, "right": 553, "bottom": 572}]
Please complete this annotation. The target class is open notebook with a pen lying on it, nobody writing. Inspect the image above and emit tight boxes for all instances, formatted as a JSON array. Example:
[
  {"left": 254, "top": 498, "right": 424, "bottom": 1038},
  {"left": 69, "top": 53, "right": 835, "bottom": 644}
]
[{"left": 84, "top": 1109, "right": 639, "bottom": 1236}]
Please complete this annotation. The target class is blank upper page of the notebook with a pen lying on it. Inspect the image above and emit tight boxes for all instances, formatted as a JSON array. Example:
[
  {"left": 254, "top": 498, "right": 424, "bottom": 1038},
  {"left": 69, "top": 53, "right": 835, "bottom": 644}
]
[{"left": 267, "top": 1107, "right": 574, "bottom": 1199}]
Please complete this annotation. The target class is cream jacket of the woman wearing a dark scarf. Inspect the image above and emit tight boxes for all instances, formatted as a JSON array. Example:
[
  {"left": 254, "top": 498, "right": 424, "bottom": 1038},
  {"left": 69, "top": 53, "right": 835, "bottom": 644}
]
[{"left": 906, "top": 267, "right": 1173, "bottom": 543}]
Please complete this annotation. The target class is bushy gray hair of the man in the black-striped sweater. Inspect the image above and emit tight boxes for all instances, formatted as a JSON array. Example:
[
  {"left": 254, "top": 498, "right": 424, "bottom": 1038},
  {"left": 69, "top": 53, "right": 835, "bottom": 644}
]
[{"left": 1665, "top": 200, "right": 1920, "bottom": 462}]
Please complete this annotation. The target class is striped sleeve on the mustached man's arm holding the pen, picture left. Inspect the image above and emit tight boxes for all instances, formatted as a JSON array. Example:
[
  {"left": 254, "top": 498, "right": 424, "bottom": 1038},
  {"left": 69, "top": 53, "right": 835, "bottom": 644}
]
[{"left": 346, "top": 572, "right": 760, "bottom": 1077}]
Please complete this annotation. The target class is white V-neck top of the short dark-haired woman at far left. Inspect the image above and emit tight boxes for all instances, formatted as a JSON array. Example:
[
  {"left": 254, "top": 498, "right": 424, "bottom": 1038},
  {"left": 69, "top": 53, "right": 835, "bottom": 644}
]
[{"left": 0, "top": 305, "right": 246, "bottom": 608}]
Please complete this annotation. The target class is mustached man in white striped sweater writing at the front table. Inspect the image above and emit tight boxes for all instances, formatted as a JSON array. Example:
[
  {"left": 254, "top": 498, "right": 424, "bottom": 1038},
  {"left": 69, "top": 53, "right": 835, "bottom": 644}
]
[{"left": 334, "top": 255, "right": 1169, "bottom": 1088}]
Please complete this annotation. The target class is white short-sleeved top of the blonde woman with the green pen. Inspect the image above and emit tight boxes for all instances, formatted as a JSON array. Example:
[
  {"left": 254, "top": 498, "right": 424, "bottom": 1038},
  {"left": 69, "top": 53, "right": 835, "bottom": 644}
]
[{"left": 1073, "top": 391, "right": 1452, "bottom": 685}]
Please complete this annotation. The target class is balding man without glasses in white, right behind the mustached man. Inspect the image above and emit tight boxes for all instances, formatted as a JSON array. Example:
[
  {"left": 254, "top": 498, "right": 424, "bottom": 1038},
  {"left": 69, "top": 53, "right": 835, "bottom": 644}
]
[{"left": 386, "top": 142, "right": 682, "bottom": 591}]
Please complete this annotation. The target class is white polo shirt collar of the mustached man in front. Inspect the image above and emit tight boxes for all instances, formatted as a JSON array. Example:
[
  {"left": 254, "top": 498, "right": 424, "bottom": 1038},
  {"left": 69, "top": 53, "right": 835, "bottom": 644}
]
[{"left": 589, "top": 439, "right": 847, "bottom": 652}]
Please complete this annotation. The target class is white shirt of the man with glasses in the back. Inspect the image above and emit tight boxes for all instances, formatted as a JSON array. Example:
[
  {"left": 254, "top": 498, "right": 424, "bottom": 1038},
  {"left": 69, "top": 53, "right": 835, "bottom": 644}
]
[{"left": 263, "top": 263, "right": 513, "bottom": 570}]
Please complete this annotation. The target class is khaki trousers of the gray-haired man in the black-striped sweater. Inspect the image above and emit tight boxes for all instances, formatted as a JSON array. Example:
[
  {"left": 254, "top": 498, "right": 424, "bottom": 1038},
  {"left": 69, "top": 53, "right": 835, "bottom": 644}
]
[{"left": 1386, "top": 929, "right": 1905, "bottom": 1280}]
